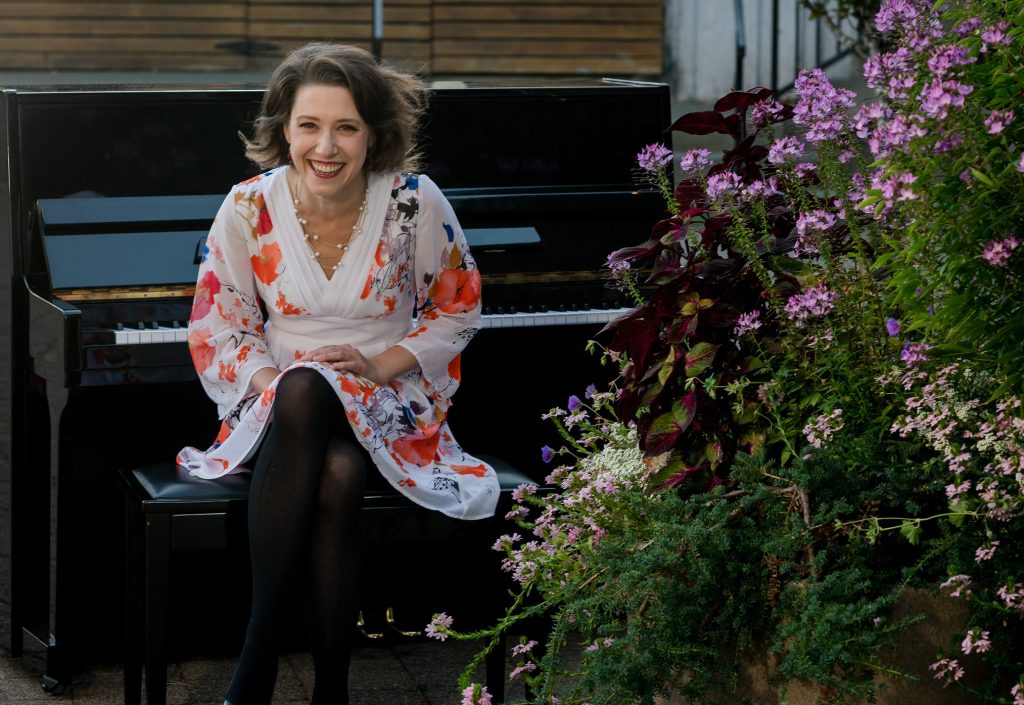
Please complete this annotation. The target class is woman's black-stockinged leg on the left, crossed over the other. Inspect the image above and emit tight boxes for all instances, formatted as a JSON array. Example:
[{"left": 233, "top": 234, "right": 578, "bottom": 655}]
[{"left": 227, "top": 368, "right": 345, "bottom": 705}]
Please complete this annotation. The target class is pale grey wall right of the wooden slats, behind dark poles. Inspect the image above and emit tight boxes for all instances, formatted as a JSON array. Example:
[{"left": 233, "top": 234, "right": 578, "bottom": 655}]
[{"left": 665, "top": 0, "right": 860, "bottom": 102}]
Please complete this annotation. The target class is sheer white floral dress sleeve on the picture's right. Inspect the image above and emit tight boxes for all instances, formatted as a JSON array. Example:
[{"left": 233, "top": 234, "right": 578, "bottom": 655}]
[{"left": 398, "top": 176, "right": 480, "bottom": 398}]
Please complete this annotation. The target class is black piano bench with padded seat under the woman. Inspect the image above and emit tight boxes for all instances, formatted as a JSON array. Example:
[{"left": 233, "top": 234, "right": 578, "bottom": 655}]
[{"left": 121, "top": 455, "right": 536, "bottom": 705}]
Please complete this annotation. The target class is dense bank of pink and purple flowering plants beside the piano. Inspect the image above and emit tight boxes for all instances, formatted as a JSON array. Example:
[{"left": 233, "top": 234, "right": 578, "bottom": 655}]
[{"left": 430, "top": 0, "right": 1024, "bottom": 705}]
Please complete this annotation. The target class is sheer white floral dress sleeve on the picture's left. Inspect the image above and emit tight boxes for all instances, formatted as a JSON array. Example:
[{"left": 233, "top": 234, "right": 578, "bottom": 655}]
[{"left": 188, "top": 186, "right": 276, "bottom": 418}]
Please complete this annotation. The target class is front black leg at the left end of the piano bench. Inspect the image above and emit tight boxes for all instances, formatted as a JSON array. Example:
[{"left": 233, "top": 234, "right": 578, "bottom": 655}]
[{"left": 145, "top": 513, "right": 171, "bottom": 705}]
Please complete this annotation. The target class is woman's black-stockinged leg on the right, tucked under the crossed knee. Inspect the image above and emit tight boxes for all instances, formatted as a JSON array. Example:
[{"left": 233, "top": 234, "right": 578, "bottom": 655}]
[{"left": 309, "top": 427, "right": 370, "bottom": 705}]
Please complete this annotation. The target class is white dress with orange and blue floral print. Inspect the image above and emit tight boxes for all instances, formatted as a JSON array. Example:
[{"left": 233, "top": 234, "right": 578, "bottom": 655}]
[{"left": 177, "top": 167, "right": 499, "bottom": 520}]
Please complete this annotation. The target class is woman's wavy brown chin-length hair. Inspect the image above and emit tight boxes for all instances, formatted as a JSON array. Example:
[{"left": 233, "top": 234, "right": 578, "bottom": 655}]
[{"left": 240, "top": 42, "right": 427, "bottom": 171}]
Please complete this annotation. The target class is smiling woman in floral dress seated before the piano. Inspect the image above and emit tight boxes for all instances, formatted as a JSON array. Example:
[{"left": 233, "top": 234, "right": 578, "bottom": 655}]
[{"left": 178, "top": 44, "right": 498, "bottom": 705}]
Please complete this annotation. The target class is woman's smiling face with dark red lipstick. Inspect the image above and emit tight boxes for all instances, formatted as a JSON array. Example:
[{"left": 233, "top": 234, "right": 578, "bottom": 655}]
[{"left": 285, "top": 85, "right": 373, "bottom": 200}]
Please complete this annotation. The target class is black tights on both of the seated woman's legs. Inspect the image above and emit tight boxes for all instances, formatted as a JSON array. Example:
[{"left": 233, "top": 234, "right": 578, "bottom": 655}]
[{"left": 227, "top": 368, "right": 368, "bottom": 705}]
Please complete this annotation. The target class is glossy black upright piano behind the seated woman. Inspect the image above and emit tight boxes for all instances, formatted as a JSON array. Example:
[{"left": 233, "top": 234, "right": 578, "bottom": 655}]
[{"left": 0, "top": 80, "right": 671, "bottom": 682}]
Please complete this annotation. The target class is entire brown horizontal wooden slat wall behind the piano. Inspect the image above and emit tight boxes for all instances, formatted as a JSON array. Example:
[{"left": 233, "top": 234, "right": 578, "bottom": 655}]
[{"left": 0, "top": 0, "right": 664, "bottom": 76}]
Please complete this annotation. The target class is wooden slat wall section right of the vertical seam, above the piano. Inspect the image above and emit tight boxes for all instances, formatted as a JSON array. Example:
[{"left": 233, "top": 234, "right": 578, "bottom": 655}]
[{"left": 432, "top": 0, "right": 664, "bottom": 76}]
